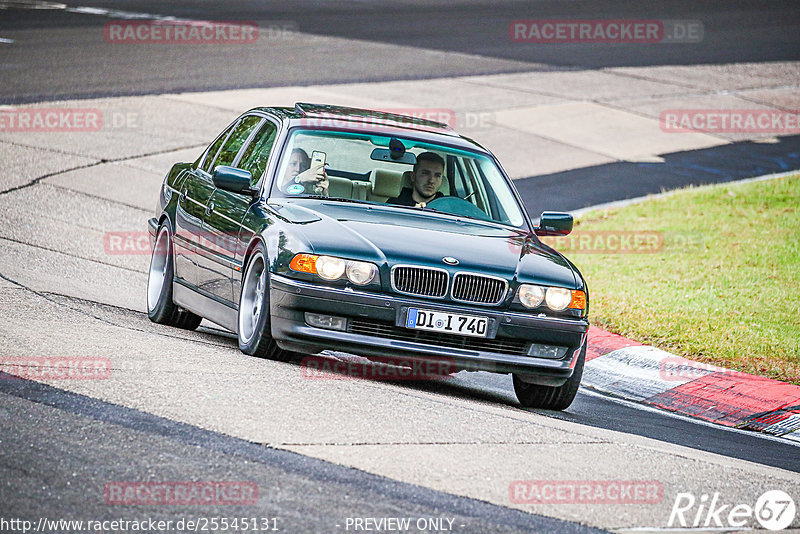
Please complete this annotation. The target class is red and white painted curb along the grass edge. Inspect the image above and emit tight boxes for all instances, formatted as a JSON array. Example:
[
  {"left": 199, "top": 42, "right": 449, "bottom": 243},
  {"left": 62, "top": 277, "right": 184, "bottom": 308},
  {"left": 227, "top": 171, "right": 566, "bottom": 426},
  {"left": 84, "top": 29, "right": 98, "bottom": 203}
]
[{"left": 581, "top": 327, "right": 800, "bottom": 442}]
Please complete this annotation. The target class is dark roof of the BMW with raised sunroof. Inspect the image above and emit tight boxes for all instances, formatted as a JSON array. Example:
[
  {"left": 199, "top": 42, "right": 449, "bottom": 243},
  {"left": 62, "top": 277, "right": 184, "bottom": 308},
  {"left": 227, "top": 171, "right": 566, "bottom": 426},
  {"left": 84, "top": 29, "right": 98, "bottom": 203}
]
[{"left": 251, "top": 102, "right": 488, "bottom": 153}]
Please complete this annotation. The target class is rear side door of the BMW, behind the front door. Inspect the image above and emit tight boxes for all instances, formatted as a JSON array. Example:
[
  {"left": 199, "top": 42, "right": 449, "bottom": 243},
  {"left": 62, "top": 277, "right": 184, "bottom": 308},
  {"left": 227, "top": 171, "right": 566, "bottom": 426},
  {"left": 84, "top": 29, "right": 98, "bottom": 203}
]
[{"left": 173, "top": 120, "right": 240, "bottom": 286}]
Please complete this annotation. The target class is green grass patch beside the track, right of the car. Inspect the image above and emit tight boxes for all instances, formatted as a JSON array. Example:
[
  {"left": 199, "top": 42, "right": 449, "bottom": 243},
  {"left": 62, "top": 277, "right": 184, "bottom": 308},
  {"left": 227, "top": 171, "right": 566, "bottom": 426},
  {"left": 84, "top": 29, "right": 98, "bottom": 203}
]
[{"left": 548, "top": 175, "right": 800, "bottom": 384}]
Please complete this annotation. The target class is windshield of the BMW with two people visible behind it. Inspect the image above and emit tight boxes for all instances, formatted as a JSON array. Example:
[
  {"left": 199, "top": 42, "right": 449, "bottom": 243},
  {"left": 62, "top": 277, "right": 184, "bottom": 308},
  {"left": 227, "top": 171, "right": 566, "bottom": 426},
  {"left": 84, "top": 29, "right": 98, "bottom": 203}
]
[{"left": 270, "top": 129, "right": 525, "bottom": 227}]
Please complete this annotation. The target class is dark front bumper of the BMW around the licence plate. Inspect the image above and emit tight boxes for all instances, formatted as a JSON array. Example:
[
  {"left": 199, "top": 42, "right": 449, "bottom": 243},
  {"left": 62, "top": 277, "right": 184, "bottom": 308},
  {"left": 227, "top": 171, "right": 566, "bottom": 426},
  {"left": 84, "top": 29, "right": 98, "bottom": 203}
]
[{"left": 270, "top": 274, "right": 589, "bottom": 386}]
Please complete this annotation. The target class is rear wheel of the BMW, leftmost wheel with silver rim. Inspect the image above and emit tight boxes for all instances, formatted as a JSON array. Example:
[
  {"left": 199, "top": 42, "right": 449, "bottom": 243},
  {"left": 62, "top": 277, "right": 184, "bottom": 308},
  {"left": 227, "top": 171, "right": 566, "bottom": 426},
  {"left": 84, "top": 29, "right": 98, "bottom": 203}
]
[{"left": 147, "top": 224, "right": 203, "bottom": 330}]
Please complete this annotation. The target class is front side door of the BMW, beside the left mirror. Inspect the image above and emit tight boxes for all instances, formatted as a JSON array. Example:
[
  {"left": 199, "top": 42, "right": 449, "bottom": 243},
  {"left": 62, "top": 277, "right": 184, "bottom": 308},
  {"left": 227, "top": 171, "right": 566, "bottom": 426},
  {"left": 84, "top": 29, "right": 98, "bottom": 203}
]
[{"left": 196, "top": 115, "right": 265, "bottom": 304}]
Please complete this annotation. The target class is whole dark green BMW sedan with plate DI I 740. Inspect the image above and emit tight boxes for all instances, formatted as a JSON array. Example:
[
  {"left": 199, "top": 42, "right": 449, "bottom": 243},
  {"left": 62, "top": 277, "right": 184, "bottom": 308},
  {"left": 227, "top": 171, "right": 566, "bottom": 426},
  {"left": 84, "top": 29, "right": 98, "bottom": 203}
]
[{"left": 147, "top": 104, "right": 589, "bottom": 409}]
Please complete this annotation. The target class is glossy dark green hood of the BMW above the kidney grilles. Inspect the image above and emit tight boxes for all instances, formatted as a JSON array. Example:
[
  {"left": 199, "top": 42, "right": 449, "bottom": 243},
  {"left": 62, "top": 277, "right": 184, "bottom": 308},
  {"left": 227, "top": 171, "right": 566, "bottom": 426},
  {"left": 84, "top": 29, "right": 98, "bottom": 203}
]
[{"left": 275, "top": 200, "right": 576, "bottom": 287}]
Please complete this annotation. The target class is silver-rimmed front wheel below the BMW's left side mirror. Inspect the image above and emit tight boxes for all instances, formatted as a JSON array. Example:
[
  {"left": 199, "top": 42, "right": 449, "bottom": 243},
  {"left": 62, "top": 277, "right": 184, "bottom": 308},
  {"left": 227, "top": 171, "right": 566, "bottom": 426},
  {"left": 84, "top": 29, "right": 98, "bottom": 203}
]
[{"left": 236, "top": 242, "right": 297, "bottom": 361}]
